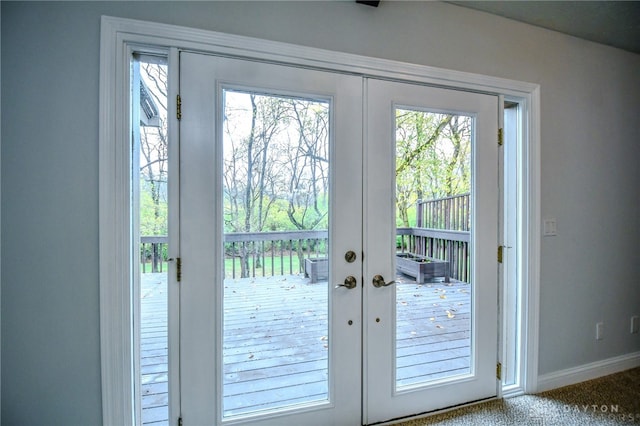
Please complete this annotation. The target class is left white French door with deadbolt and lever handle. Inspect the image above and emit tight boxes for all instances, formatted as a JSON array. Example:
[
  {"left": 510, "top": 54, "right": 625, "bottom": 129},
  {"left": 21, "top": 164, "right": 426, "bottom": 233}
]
[{"left": 180, "top": 53, "right": 362, "bottom": 425}]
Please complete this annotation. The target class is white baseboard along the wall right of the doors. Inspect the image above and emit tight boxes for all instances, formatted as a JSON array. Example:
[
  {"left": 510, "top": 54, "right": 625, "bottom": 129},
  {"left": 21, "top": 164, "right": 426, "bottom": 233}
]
[{"left": 538, "top": 352, "right": 640, "bottom": 392}]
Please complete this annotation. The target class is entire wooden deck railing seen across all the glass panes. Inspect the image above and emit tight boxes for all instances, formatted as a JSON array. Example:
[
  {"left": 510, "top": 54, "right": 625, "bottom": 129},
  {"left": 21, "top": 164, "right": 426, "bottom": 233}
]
[{"left": 140, "top": 194, "right": 471, "bottom": 281}]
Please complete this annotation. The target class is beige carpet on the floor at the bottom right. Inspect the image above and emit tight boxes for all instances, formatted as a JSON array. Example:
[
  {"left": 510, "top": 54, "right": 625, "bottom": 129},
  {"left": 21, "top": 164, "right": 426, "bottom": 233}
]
[{"left": 390, "top": 368, "right": 640, "bottom": 426}]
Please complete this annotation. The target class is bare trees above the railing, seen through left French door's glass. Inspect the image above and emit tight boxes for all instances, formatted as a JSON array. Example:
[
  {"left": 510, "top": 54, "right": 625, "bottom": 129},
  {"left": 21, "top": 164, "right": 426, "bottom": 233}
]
[{"left": 223, "top": 91, "right": 329, "bottom": 277}]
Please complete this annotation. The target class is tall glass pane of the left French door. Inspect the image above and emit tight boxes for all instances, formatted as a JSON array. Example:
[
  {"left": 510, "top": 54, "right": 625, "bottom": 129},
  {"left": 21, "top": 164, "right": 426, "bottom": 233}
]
[{"left": 222, "top": 89, "right": 330, "bottom": 417}]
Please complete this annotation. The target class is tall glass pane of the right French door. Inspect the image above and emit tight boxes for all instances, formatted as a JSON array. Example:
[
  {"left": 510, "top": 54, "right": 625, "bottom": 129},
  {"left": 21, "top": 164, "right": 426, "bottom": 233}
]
[{"left": 395, "top": 108, "right": 473, "bottom": 389}]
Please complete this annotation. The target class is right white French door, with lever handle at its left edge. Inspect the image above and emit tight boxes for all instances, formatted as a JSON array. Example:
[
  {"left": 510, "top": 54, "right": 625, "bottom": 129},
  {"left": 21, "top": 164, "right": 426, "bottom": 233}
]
[{"left": 363, "top": 80, "right": 498, "bottom": 423}]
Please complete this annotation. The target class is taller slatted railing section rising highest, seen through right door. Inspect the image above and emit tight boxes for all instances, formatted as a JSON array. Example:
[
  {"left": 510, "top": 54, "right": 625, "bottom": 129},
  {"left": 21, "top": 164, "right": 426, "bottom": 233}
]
[{"left": 416, "top": 193, "right": 471, "bottom": 231}]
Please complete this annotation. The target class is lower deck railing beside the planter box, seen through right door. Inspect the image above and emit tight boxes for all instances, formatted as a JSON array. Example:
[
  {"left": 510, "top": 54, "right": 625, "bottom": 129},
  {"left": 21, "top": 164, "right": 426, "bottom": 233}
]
[{"left": 396, "top": 228, "right": 471, "bottom": 282}]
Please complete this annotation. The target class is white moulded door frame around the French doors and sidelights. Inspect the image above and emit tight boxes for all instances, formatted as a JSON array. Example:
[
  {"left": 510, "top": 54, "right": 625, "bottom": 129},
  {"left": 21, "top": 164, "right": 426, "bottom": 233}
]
[{"left": 98, "top": 16, "right": 540, "bottom": 425}]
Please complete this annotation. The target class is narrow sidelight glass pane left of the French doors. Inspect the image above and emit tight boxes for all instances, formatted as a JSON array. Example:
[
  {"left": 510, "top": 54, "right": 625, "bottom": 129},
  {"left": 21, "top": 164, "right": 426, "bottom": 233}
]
[{"left": 131, "top": 54, "right": 169, "bottom": 425}]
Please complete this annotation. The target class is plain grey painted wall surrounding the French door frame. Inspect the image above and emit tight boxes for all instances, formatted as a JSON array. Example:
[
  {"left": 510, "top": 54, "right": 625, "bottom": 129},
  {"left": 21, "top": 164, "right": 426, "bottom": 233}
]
[{"left": 0, "top": 1, "right": 640, "bottom": 425}]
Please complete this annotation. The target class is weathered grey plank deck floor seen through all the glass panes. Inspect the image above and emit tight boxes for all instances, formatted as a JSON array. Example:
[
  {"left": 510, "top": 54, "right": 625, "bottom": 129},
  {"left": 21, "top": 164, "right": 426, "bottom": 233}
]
[{"left": 141, "top": 274, "right": 470, "bottom": 425}]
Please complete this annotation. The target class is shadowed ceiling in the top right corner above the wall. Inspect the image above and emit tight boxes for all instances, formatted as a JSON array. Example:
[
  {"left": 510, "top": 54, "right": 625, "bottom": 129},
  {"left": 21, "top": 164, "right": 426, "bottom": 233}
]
[{"left": 449, "top": 0, "right": 640, "bottom": 53}]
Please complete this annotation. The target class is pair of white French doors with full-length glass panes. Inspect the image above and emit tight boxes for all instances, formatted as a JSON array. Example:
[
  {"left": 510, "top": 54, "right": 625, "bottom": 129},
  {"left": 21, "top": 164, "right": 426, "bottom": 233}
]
[{"left": 179, "top": 53, "right": 498, "bottom": 425}]
